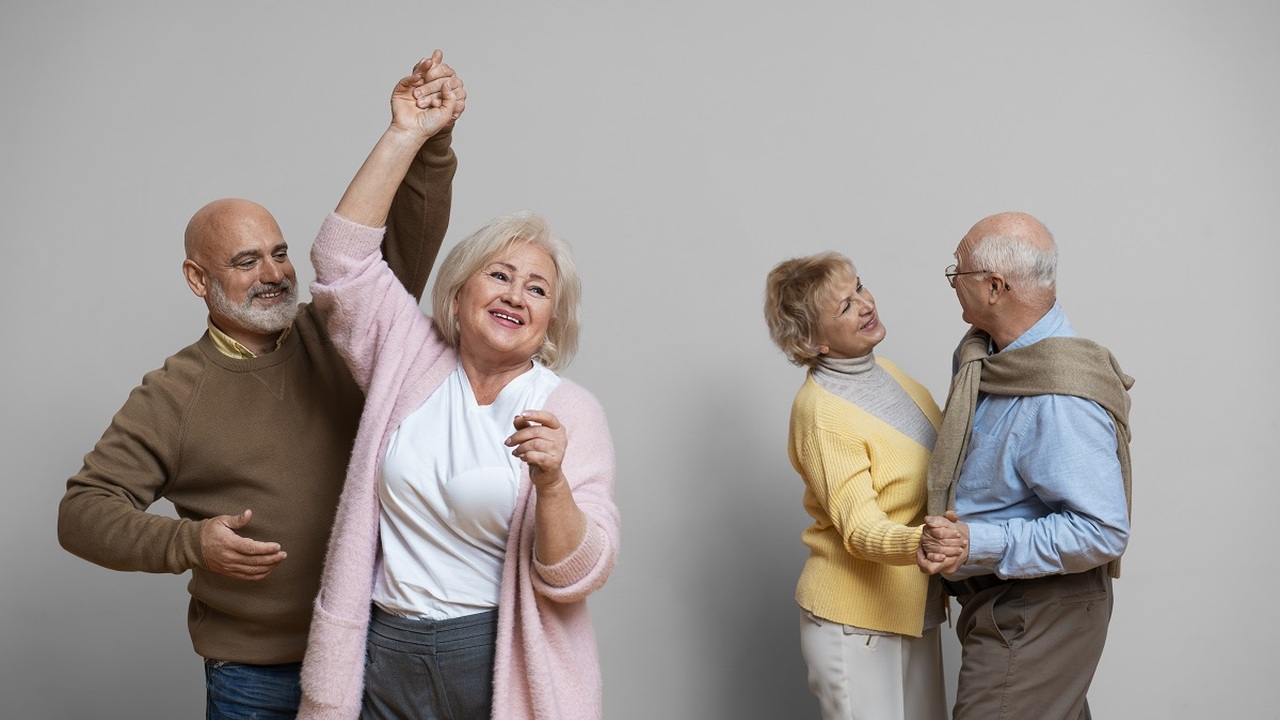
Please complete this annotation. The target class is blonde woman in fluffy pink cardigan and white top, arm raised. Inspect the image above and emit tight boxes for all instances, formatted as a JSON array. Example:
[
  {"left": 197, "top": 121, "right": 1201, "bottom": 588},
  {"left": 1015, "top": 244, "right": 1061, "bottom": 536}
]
[{"left": 298, "top": 56, "right": 618, "bottom": 720}]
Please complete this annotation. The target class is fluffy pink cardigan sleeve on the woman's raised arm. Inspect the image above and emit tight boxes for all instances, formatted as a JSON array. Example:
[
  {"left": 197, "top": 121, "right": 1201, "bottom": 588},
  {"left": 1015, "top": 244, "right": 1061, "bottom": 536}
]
[{"left": 311, "top": 214, "right": 444, "bottom": 395}]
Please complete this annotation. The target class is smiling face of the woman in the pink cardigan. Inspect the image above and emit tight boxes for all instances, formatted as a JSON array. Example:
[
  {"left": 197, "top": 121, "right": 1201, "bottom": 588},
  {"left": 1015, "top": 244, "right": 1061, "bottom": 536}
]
[{"left": 454, "top": 242, "right": 557, "bottom": 365}]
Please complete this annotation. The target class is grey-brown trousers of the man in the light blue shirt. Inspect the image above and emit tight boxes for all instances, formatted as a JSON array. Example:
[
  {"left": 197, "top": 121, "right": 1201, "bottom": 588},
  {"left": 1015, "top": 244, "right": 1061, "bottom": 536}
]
[{"left": 951, "top": 566, "right": 1112, "bottom": 720}]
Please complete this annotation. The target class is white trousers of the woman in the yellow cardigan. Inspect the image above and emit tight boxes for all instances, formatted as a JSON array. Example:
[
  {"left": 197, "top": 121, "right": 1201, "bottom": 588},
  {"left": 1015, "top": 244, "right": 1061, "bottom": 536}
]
[{"left": 800, "top": 609, "right": 947, "bottom": 720}]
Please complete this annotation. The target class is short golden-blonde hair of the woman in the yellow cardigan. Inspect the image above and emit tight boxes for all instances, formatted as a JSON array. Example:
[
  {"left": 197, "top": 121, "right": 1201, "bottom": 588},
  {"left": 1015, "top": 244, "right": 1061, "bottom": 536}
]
[{"left": 764, "top": 252, "right": 856, "bottom": 368}]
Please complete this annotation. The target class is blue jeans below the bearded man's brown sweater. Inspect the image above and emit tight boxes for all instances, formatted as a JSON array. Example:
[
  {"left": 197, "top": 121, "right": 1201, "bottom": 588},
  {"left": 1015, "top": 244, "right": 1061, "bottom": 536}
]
[{"left": 205, "top": 660, "right": 302, "bottom": 720}]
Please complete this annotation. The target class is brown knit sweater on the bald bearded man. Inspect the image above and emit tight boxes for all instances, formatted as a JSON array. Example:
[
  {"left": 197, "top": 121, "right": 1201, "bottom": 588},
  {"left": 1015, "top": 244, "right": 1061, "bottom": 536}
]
[{"left": 58, "top": 133, "right": 457, "bottom": 664}]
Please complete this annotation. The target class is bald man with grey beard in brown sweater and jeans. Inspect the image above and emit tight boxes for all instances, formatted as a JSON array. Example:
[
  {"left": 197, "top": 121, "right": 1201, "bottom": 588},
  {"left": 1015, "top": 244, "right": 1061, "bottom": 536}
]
[{"left": 58, "top": 51, "right": 465, "bottom": 719}]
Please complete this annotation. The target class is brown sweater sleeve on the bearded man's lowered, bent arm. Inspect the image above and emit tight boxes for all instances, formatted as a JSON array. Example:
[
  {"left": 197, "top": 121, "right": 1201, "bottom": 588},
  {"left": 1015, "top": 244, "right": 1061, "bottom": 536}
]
[{"left": 58, "top": 359, "right": 204, "bottom": 573}]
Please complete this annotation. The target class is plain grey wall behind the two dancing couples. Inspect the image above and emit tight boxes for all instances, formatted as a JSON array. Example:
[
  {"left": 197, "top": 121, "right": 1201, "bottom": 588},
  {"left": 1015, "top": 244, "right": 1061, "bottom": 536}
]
[{"left": 0, "top": 0, "right": 1280, "bottom": 720}]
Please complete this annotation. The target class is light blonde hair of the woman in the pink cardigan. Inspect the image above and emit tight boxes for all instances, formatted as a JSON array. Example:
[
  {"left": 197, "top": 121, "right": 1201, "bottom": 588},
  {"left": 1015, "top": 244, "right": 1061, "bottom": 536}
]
[{"left": 431, "top": 210, "right": 582, "bottom": 370}]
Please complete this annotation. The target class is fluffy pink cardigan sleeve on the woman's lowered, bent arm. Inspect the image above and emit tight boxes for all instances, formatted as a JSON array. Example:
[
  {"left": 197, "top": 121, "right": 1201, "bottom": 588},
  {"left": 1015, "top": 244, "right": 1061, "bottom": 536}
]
[{"left": 532, "top": 380, "right": 621, "bottom": 602}]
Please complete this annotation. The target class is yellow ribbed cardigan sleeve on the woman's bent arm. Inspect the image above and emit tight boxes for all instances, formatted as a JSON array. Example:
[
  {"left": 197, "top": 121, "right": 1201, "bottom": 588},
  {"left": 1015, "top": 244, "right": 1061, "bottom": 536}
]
[{"left": 796, "top": 428, "right": 922, "bottom": 565}]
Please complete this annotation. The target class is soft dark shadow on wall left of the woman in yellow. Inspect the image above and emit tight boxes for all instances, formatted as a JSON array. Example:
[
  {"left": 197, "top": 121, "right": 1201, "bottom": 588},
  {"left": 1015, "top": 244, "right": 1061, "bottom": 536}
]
[{"left": 682, "top": 374, "right": 818, "bottom": 720}]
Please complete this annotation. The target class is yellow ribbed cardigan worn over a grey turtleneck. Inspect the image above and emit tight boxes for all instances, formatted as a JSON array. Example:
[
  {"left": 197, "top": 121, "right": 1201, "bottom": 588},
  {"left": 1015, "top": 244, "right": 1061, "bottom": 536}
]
[{"left": 788, "top": 359, "right": 942, "bottom": 637}]
